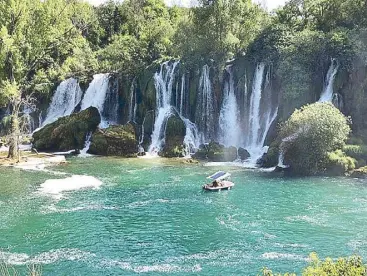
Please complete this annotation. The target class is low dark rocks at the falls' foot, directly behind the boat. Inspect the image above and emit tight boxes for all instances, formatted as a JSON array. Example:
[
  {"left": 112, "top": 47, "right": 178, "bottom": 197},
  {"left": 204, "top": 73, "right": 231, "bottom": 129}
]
[{"left": 193, "top": 142, "right": 237, "bottom": 162}]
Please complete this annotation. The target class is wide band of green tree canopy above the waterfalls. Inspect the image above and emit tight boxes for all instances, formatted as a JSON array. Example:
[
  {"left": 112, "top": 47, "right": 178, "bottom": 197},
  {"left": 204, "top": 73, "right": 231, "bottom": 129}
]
[{"left": 0, "top": 0, "right": 367, "bottom": 160}]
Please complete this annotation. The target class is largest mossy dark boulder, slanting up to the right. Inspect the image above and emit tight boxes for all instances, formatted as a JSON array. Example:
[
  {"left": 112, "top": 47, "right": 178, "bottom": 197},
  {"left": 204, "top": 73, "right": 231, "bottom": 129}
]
[{"left": 33, "top": 107, "right": 101, "bottom": 151}]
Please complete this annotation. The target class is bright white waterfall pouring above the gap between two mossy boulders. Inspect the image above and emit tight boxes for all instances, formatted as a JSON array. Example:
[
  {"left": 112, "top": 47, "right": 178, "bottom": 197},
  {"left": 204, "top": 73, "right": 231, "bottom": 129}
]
[{"left": 81, "top": 74, "right": 110, "bottom": 127}]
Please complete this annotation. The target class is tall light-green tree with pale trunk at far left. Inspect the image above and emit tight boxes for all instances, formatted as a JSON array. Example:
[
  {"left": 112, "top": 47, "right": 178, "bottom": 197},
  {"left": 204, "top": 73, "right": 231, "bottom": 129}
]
[{"left": 0, "top": 0, "right": 96, "bottom": 159}]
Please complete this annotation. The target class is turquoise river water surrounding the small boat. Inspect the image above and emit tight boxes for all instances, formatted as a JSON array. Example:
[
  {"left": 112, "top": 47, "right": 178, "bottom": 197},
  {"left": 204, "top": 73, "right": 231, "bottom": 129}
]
[{"left": 0, "top": 158, "right": 367, "bottom": 275}]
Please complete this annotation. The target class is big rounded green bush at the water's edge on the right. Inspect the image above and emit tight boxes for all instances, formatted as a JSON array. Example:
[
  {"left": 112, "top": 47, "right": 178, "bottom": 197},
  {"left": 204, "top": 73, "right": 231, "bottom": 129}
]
[{"left": 280, "top": 103, "right": 353, "bottom": 174}]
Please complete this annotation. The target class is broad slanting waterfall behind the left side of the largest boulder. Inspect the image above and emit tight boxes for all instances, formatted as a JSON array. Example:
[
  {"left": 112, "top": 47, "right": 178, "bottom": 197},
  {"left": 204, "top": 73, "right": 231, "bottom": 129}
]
[{"left": 40, "top": 78, "right": 83, "bottom": 127}]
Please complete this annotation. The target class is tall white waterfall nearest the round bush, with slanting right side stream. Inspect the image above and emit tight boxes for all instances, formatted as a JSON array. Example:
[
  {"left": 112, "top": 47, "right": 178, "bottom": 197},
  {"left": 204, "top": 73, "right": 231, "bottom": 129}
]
[{"left": 245, "top": 63, "right": 278, "bottom": 163}]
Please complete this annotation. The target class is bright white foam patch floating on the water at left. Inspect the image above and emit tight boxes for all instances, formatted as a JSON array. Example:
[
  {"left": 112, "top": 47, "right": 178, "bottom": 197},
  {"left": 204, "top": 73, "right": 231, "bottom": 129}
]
[{"left": 39, "top": 175, "right": 102, "bottom": 199}]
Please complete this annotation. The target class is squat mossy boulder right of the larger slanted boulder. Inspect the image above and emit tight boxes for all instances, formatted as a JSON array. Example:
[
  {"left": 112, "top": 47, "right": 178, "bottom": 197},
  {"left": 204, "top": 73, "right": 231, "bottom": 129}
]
[{"left": 88, "top": 123, "right": 138, "bottom": 157}]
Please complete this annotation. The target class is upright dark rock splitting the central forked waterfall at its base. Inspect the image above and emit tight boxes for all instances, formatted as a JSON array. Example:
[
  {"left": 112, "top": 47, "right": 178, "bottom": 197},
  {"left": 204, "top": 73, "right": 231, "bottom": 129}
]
[{"left": 160, "top": 115, "right": 186, "bottom": 157}]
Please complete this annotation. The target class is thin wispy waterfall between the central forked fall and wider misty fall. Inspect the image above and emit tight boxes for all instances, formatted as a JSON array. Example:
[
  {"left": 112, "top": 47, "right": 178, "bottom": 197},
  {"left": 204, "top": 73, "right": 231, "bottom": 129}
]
[{"left": 195, "top": 65, "right": 215, "bottom": 143}]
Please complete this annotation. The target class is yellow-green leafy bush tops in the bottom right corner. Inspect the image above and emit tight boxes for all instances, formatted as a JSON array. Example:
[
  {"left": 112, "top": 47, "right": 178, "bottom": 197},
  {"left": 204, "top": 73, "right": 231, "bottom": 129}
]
[{"left": 263, "top": 253, "right": 367, "bottom": 276}]
